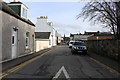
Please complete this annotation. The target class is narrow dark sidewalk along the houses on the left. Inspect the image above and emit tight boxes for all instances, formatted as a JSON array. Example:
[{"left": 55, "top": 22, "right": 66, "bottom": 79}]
[{"left": 2, "top": 48, "right": 51, "bottom": 71}]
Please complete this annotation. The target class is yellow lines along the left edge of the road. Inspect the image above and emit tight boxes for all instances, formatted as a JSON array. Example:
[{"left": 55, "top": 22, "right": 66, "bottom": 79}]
[{"left": 0, "top": 51, "right": 48, "bottom": 78}]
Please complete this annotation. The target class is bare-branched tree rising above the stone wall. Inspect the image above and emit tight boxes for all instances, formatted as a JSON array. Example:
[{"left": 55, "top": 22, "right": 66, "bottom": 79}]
[{"left": 77, "top": 1, "right": 120, "bottom": 39}]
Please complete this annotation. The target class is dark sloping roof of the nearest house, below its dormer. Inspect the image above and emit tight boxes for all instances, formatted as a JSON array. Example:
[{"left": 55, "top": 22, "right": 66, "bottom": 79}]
[{"left": 2, "top": 2, "right": 35, "bottom": 26}]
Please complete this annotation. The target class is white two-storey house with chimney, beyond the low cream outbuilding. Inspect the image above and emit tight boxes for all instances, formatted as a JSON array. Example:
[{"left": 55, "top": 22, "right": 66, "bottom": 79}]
[{"left": 35, "top": 16, "right": 61, "bottom": 47}]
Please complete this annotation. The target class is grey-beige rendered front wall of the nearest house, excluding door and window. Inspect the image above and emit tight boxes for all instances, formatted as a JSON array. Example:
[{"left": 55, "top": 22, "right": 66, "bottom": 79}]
[{"left": 2, "top": 12, "right": 35, "bottom": 60}]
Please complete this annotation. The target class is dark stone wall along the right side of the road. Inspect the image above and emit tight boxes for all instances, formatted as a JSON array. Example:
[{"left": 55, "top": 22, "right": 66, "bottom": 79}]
[{"left": 87, "top": 40, "right": 120, "bottom": 61}]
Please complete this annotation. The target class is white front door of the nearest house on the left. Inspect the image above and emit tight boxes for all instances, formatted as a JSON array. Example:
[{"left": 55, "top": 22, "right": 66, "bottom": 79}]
[{"left": 12, "top": 29, "right": 17, "bottom": 59}]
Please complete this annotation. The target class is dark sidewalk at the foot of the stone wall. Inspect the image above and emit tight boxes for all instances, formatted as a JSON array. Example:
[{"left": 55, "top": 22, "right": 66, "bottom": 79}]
[{"left": 89, "top": 53, "right": 120, "bottom": 73}]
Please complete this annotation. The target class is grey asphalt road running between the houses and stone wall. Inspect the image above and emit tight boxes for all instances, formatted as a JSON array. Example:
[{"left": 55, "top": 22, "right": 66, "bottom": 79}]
[{"left": 3, "top": 44, "right": 118, "bottom": 80}]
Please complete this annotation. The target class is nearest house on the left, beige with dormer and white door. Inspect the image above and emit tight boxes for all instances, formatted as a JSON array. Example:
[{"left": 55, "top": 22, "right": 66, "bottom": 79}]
[{"left": 0, "top": 2, "right": 35, "bottom": 61}]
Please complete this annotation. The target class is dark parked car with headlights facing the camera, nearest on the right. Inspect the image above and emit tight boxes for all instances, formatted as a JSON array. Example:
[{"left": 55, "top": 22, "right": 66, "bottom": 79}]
[{"left": 71, "top": 41, "right": 87, "bottom": 54}]
